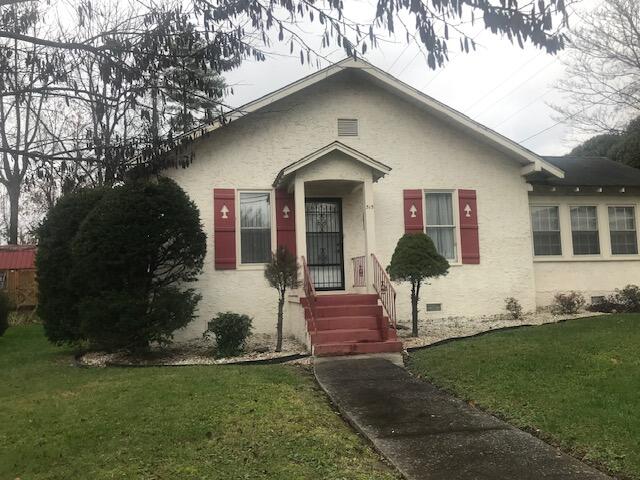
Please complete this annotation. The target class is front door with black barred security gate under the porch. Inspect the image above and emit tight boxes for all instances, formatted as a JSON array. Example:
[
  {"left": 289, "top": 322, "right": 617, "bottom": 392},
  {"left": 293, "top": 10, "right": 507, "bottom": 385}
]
[{"left": 305, "top": 198, "right": 344, "bottom": 290}]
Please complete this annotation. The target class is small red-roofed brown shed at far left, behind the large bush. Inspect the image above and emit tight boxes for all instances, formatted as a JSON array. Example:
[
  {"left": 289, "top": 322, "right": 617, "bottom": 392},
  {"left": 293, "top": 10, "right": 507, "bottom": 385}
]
[{"left": 0, "top": 245, "right": 38, "bottom": 309}]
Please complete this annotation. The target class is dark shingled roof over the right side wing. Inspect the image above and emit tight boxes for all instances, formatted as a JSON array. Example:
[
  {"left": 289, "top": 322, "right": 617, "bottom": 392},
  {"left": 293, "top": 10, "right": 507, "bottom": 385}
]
[{"left": 529, "top": 156, "right": 640, "bottom": 187}]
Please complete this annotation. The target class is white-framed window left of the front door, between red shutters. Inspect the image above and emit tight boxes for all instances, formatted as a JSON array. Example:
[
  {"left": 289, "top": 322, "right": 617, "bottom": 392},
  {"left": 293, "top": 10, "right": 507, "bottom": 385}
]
[{"left": 240, "top": 192, "right": 271, "bottom": 263}]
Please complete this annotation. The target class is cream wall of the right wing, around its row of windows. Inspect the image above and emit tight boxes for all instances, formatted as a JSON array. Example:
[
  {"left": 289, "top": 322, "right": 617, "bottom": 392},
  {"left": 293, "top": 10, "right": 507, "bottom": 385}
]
[{"left": 530, "top": 194, "right": 640, "bottom": 306}]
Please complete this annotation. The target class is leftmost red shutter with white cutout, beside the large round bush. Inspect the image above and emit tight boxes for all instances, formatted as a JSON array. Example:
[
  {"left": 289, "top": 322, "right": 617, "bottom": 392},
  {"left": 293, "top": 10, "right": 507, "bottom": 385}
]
[{"left": 213, "top": 188, "right": 236, "bottom": 270}]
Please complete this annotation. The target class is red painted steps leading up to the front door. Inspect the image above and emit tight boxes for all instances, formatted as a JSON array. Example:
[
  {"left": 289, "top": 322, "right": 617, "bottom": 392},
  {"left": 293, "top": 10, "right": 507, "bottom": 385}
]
[{"left": 301, "top": 294, "right": 402, "bottom": 356}]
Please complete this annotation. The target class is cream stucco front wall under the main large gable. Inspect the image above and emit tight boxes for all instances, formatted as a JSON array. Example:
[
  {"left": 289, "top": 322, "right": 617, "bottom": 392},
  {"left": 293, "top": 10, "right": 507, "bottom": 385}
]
[{"left": 166, "top": 72, "right": 535, "bottom": 338}]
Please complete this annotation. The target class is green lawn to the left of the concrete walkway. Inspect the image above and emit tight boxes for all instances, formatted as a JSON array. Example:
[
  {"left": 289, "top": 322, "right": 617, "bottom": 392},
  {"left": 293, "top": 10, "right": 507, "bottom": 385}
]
[{"left": 0, "top": 325, "right": 398, "bottom": 480}]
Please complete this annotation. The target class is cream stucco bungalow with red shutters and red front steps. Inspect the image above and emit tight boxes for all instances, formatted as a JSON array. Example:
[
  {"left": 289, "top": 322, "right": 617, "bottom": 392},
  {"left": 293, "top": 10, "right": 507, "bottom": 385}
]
[{"left": 166, "top": 59, "right": 640, "bottom": 354}]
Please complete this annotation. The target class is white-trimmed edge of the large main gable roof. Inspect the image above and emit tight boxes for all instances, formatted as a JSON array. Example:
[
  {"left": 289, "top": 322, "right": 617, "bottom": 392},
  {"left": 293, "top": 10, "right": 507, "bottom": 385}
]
[{"left": 178, "top": 58, "right": 564, "bottom": 178}]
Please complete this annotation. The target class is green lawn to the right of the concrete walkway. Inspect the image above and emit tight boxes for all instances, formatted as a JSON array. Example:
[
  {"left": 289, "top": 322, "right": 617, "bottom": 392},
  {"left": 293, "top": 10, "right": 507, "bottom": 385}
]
[{"left": 410, "top": 315, "right": 640, "bottom": 479}]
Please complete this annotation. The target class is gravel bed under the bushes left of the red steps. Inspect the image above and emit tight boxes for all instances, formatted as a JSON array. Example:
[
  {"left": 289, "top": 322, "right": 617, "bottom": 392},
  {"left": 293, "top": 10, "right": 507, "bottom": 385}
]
[{"left": 77, "top": 334, "right": 308, "bottom": 367}]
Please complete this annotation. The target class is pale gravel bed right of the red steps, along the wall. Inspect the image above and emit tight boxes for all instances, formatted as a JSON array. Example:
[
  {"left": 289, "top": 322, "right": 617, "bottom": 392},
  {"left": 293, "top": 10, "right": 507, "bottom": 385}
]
[{"left": 398, "top": 310, "right": 603, "bottom": 349}]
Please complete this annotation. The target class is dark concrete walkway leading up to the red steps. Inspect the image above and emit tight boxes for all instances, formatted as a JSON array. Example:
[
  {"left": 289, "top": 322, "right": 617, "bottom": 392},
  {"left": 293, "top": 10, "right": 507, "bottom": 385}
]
[{"left": 314, "top": 358, "right": 610, "bottom": 480}]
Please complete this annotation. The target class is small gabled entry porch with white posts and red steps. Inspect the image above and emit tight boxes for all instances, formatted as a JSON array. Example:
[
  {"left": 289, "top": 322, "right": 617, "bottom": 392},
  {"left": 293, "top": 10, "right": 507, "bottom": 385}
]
[{"left": 274, "top": 142, "right": 402, "bottom": 355}]
